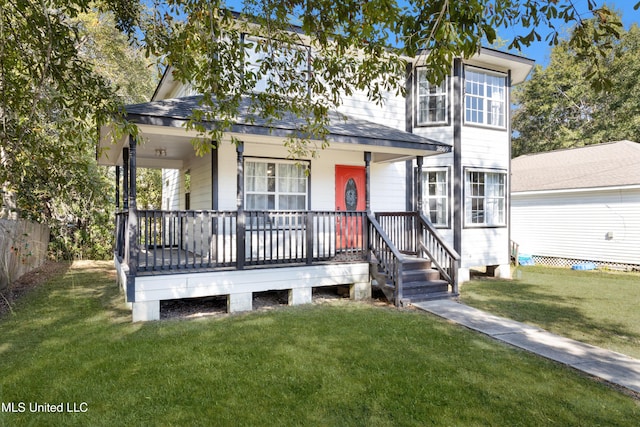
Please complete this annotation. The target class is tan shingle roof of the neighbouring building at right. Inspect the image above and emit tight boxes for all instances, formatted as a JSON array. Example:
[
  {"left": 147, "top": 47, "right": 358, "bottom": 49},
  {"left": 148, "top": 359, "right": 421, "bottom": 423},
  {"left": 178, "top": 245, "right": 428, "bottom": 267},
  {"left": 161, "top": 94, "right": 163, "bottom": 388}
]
[{"left": 511, "top": 141, "right": 640, "bottom": 193}]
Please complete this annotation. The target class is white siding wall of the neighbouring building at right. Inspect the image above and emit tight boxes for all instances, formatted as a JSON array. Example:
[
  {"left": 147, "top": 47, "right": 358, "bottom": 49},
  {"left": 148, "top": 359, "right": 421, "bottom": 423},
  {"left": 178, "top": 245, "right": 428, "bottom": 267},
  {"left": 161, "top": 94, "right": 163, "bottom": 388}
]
[{"left": 511, "top": 188, "right": 640, "bottom": 265}]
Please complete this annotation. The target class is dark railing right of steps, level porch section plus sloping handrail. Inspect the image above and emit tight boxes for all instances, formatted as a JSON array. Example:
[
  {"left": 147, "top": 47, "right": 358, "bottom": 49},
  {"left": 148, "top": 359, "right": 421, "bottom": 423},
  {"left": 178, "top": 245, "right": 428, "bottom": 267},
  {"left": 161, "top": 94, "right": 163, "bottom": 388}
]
[{"left": 376, "top": 212, "right": 460, "bottom": 294}]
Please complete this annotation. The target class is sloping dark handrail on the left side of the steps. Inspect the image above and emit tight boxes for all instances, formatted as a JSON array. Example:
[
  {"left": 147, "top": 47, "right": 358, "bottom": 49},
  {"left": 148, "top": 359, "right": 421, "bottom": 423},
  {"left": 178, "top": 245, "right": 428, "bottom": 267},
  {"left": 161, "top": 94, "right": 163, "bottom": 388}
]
[{"left": 367, "top": 212, "right": 404, "bottom": 306}]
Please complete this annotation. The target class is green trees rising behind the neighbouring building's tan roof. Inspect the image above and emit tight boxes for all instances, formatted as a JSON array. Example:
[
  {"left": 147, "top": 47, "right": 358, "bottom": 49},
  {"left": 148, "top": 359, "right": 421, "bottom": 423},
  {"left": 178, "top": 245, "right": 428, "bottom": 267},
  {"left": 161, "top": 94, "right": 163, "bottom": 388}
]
[{"left": 512, "top": 19, "right": 640, "bottom": 156}]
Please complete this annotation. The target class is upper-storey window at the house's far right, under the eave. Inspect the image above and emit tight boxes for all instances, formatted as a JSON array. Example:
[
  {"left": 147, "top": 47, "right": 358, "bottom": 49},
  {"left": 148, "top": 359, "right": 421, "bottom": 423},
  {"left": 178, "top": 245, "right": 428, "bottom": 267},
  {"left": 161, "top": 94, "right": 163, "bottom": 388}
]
[{"left": 464, "top": 68, "right": 506, "bottom": 128}]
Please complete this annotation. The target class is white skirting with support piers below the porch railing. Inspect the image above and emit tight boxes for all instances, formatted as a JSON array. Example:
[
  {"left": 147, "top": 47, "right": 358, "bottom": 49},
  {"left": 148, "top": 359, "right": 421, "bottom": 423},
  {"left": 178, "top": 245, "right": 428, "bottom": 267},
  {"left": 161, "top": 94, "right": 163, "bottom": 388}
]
[{"left": 116, "top": 254, "right": 371, "bottom": 322}]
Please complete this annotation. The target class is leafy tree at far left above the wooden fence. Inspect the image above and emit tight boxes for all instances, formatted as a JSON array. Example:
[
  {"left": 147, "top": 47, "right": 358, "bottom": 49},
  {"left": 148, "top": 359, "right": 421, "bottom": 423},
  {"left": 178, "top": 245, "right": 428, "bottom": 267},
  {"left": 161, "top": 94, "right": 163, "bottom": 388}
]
[{"left": 0, "top": 1, "right": 155, "bottom": 258}]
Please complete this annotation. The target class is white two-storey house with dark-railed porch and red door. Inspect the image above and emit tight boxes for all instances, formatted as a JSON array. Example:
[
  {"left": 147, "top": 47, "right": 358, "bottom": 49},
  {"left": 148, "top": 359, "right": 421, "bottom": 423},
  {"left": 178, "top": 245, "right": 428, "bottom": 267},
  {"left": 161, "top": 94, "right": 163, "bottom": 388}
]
[{"left": 98, "top": 26, "right": 533, "bottom": 321}]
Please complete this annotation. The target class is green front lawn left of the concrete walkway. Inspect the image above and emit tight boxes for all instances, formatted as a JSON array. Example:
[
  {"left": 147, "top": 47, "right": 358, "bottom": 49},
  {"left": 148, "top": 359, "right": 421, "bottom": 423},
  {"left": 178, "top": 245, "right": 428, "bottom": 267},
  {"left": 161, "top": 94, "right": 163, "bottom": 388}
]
[{"left": 0, "top": 263, "right": 640, "bottom": 426}]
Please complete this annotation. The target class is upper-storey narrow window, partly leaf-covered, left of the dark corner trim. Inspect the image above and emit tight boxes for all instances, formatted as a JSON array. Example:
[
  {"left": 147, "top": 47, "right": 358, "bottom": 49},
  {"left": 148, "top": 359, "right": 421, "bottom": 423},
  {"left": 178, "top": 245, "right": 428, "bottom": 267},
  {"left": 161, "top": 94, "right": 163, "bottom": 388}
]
[{"left": 417, "top": 68, "right": 449, "bottom": 125}]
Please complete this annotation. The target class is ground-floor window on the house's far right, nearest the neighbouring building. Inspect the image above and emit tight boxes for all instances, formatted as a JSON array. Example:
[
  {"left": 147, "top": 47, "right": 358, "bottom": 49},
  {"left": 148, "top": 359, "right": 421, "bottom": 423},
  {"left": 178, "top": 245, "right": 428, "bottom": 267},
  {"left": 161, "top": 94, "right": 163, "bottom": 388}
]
[{"left": 465, "top": 170, "right": 507, "bottom": 226}]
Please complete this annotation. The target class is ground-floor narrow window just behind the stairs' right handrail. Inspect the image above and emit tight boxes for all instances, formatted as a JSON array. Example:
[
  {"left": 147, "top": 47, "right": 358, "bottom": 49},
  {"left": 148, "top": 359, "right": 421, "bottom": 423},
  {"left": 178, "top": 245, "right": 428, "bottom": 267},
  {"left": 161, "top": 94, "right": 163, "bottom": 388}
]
[{"left": 422, "top": 169, "right": 449, "bottom": 227}]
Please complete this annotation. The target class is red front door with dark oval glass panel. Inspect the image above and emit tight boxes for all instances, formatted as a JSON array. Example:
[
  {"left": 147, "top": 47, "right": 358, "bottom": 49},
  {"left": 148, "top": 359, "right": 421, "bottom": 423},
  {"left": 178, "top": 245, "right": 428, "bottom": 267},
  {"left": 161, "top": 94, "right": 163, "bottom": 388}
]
[{"left": 336, "top": 165, "right": 366, "bottom": 249}]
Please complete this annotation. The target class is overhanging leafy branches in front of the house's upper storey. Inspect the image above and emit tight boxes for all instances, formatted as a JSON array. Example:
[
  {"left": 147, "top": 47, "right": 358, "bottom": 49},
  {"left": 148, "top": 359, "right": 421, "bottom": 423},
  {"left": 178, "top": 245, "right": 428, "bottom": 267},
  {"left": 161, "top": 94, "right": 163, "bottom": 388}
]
[{"left": 145, "top": 0, "right": 621, "bottom": 157}]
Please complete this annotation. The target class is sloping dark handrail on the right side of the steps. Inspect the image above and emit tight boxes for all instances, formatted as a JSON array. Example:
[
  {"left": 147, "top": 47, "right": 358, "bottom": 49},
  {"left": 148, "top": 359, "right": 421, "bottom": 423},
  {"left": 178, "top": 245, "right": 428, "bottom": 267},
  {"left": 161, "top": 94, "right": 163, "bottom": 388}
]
[{"left": 418, "top": 212, "right": 460, "bottom": 294}]
